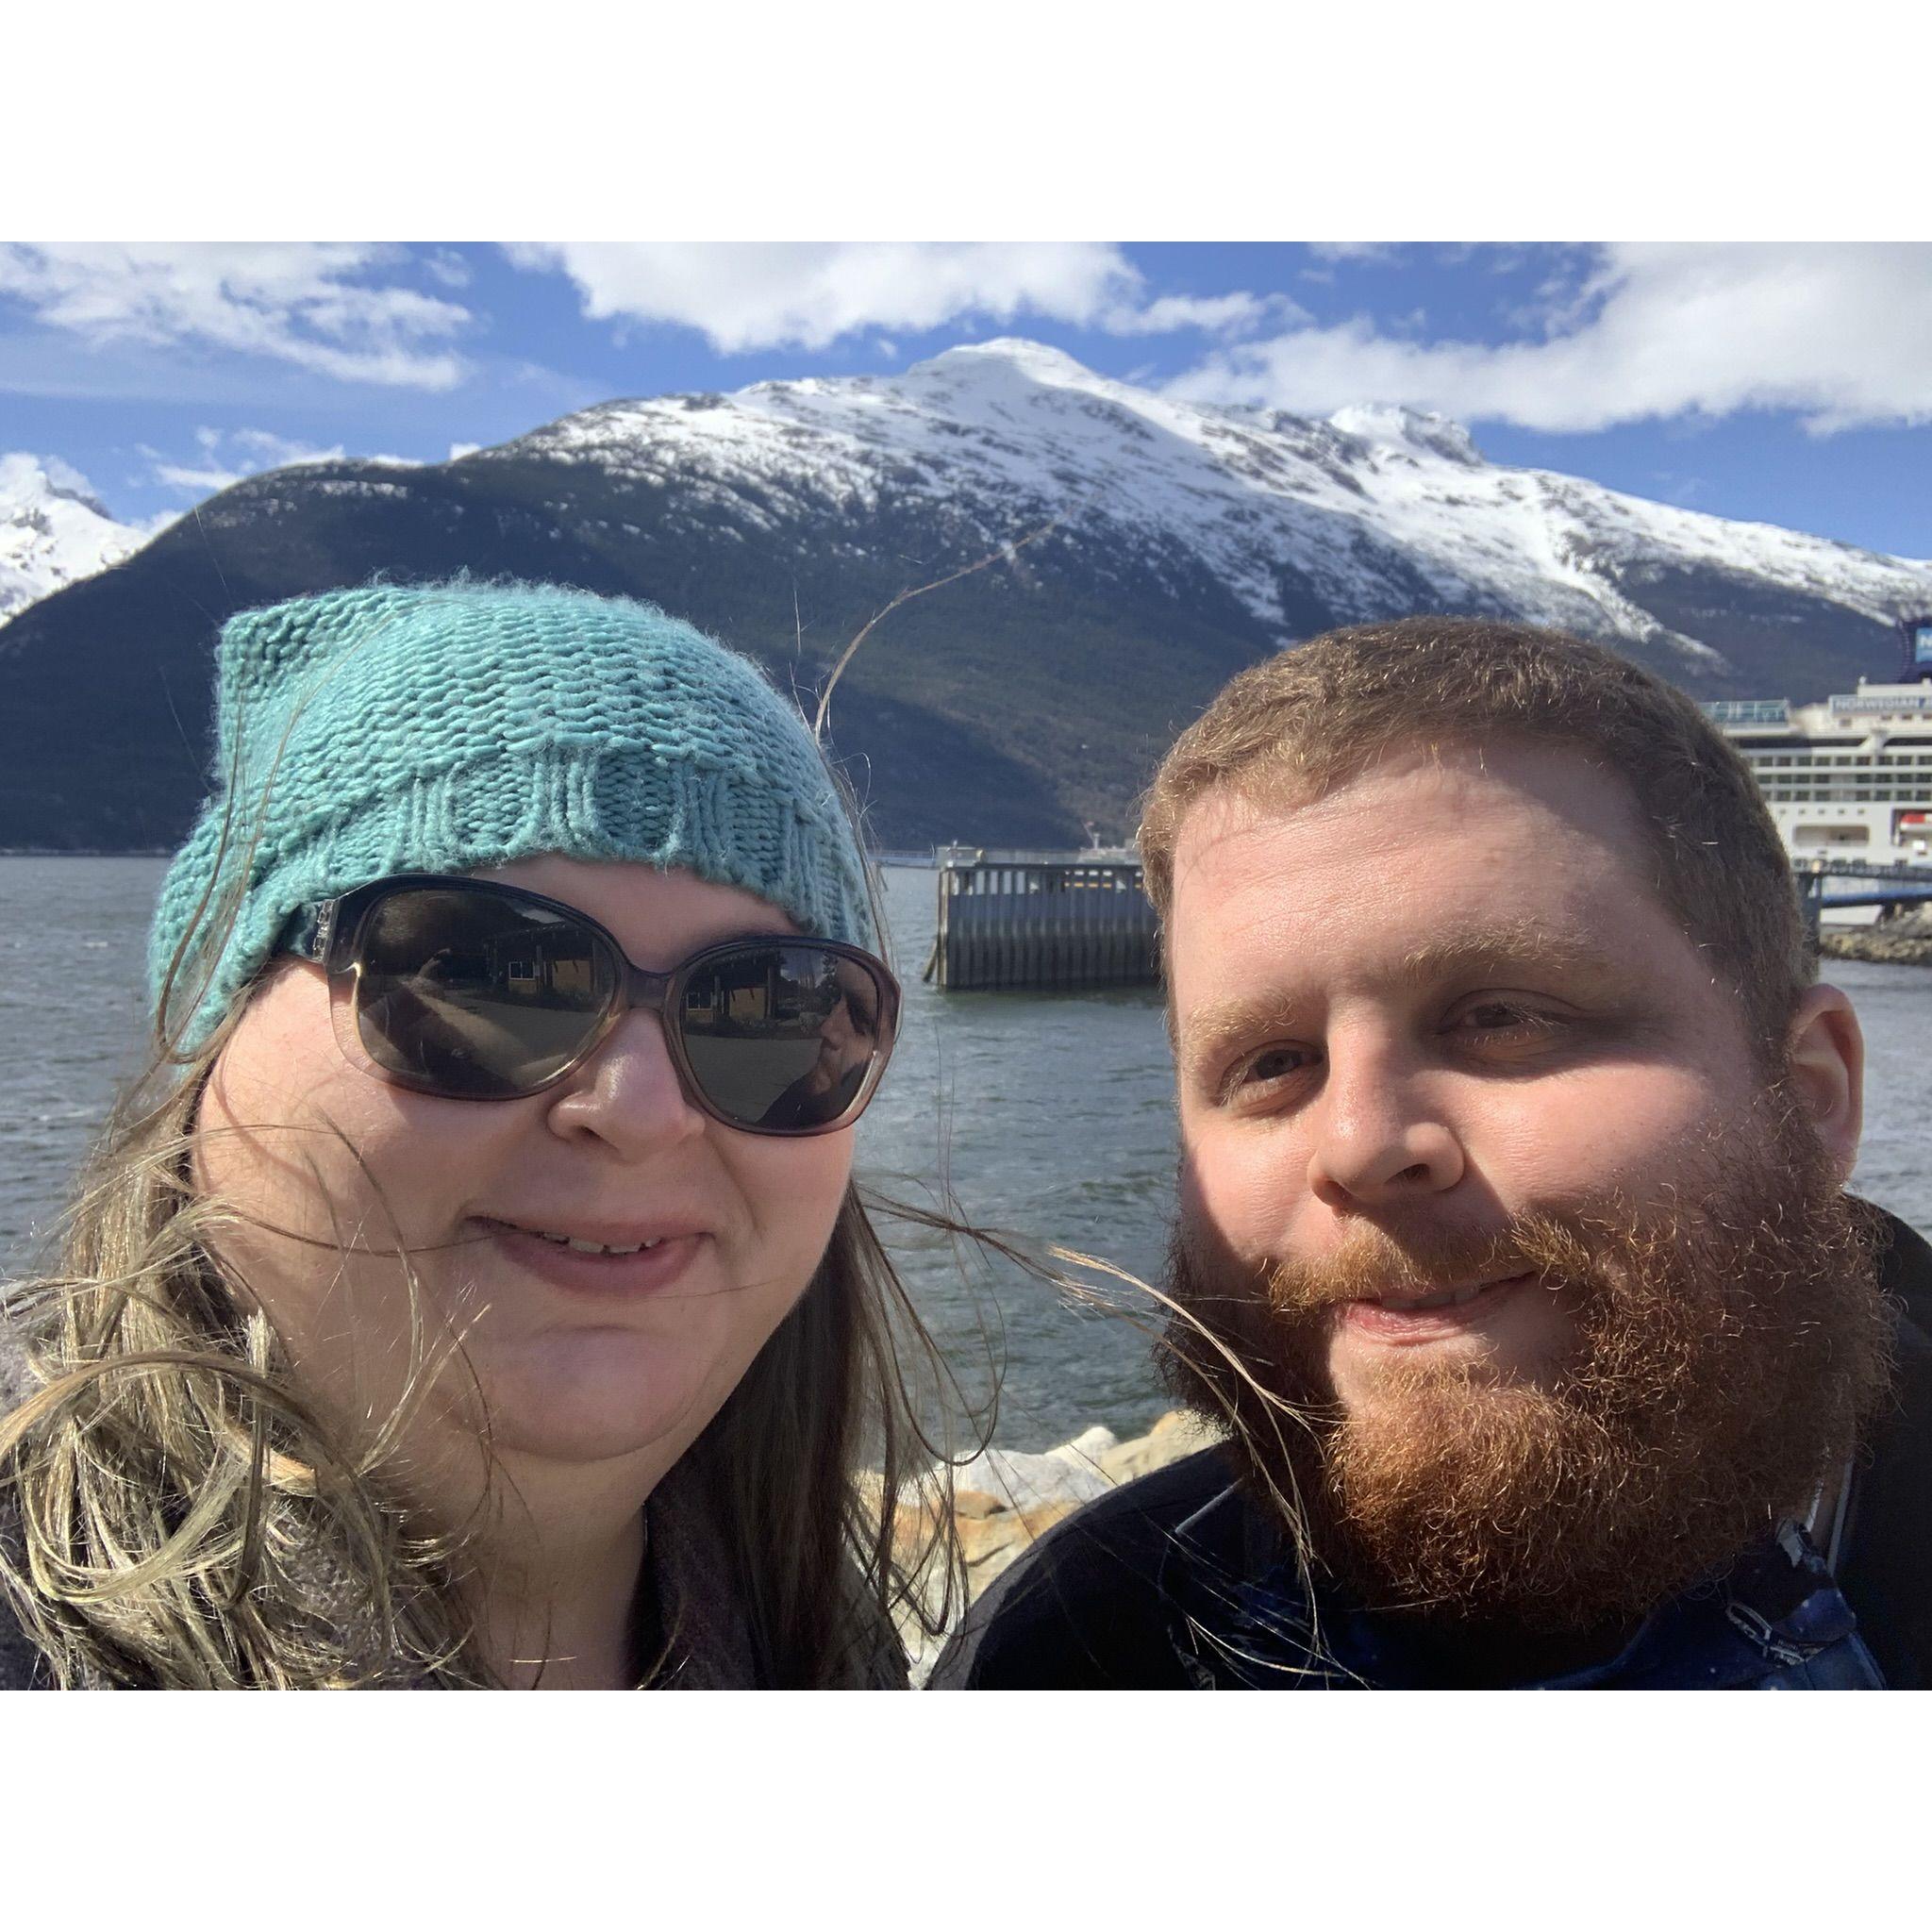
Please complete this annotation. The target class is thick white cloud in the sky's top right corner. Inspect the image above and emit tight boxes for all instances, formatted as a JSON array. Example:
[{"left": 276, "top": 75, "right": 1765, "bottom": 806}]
[{"left": 1171, "top": 242, "right": 1932, "bottom": 433}]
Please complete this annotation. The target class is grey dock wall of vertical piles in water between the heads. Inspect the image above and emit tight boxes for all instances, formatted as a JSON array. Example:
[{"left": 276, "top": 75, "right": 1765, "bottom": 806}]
[{"left": 925, "top": 846, "right": 1161, "bottom": 993}]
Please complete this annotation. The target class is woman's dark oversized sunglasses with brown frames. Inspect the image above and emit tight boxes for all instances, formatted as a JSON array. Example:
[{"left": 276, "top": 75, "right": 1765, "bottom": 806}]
[{"left": 282, "top": 874, "right": 898, "bottom": 1134}]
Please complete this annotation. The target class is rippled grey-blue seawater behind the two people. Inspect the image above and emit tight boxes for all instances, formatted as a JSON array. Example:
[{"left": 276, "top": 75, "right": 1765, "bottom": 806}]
[{"left": 0, "top": 858, "right": 1932, "bottom": 1449}]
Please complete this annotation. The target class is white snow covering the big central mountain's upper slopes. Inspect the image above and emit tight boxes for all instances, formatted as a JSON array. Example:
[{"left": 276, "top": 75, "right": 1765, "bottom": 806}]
[{"left": 483, "top": 338, "right": 1932, "bottom": 667}]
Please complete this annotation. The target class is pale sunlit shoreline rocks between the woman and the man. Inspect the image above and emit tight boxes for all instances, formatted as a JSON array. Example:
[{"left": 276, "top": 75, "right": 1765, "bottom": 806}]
[{"left": 896, "top": 1408, "right": 1215, "bottom": 1683}]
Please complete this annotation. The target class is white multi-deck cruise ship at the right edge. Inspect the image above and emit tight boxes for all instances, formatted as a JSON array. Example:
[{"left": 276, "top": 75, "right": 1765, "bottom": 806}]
[{"left": 1706, "top": 616, "right": 1932, "bottom": 866}]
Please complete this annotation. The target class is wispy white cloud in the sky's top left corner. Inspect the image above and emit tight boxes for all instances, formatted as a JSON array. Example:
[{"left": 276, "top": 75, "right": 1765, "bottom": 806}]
[{"left": 0, "top": 242, "right": 472, "bottom": 389}]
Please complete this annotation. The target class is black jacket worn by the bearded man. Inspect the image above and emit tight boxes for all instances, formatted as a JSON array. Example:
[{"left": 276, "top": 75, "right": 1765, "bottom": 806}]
[{"left": 931, "top": 1215, "right": 1932, "bottom": 1690}]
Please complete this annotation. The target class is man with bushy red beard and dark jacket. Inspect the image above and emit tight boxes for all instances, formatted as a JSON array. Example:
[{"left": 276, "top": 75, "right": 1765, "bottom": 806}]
[{"left": 935, "top": 618, "right": 1932, "bottom": 1689}]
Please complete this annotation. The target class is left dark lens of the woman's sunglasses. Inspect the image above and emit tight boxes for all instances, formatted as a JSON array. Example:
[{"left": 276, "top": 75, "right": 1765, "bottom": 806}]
[{"left": 356, "top": 887, "right": 616, "bottom": 1099}]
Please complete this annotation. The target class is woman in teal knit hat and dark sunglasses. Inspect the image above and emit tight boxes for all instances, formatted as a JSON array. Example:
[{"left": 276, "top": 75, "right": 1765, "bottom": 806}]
[{"left": 0, "top": 581, "right": 951, "bottom": 1687}]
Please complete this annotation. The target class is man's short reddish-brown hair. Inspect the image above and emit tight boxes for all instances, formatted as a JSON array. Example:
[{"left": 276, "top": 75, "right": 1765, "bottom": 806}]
[{"left": 1140, "top": 616, "right": 1814, "bottom": 1069}]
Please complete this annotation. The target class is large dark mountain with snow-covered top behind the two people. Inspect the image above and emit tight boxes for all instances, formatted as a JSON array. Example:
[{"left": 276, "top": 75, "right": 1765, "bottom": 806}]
[{"left": 0, "top": 340, "right": 1932, "bottom": 846}]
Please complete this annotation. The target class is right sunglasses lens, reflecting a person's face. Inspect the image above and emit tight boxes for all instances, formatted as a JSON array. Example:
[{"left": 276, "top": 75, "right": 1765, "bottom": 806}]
[{"left": 678, "top": 944, "right": 891, "bottom": 1132}]
